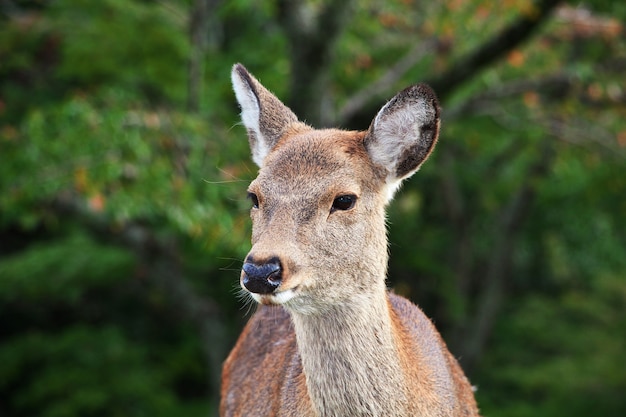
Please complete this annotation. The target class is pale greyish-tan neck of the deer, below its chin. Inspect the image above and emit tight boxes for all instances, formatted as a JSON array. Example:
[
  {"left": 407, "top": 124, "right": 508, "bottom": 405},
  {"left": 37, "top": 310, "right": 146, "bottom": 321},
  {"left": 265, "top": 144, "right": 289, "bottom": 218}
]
[{"left": 292, "top": 286, "right": 407, "bottom": 416}]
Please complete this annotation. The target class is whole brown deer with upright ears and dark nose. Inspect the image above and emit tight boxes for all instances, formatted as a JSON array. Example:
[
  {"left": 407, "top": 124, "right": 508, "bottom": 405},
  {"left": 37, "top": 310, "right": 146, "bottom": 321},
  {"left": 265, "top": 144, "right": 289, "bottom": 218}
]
[{"left": 220, "top": 64, "right": 479, "bottom": 417}]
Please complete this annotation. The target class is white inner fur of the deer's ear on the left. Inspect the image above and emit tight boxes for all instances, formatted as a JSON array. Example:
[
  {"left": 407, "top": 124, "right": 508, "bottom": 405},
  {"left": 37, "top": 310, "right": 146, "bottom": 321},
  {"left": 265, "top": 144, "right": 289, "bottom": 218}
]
[{"left": 231, "top": 71, "right": 269, "bottom": 167}]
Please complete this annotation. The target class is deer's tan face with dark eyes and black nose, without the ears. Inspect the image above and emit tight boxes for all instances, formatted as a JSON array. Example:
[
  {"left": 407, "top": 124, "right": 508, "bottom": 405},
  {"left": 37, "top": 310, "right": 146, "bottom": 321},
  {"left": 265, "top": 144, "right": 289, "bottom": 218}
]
[{"left": 241, "top": 130, "right": 387, "bottom": 312}]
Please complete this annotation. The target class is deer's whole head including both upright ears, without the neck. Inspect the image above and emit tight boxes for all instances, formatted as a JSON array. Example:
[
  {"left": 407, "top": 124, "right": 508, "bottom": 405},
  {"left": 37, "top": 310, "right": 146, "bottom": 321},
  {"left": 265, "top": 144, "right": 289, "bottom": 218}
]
[{"left": 232, "top": 64, "right": 439, "bottom": 314}]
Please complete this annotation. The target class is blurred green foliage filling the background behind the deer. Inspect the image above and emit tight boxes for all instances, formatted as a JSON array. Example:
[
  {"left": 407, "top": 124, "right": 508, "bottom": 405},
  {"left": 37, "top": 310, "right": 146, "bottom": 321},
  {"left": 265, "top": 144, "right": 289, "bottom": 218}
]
[{"left": 0, "top": 0, "right": 626, "bottom": 417}]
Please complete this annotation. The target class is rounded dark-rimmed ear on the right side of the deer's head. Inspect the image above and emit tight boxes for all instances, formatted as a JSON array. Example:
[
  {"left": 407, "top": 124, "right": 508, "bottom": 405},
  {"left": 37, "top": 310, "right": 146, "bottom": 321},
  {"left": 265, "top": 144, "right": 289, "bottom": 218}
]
[{"left": 365, "top": 84, "right": 440, "bottom": 199}]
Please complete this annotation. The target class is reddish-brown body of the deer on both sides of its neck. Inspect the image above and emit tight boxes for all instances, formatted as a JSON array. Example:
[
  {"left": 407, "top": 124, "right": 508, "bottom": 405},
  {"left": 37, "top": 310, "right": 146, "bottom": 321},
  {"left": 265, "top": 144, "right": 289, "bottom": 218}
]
[{"left": 220, "top": 293, "right": 478, "bottom": 417}]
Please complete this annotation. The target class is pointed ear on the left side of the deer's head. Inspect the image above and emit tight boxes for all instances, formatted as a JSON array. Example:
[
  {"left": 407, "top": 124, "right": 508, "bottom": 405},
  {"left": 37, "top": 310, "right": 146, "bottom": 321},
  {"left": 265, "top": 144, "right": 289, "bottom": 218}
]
[{"left": 231, "top": 64, "right": 299, "bottom": 167}]
